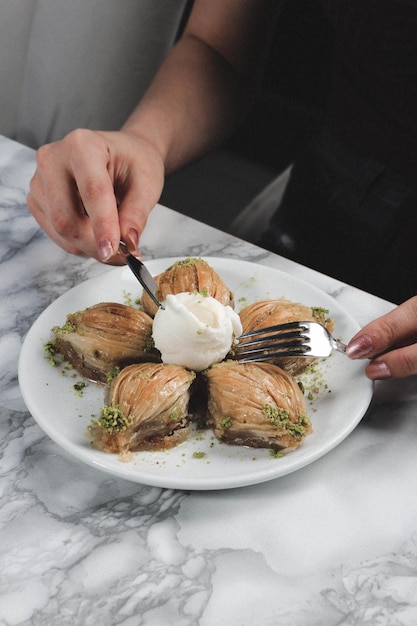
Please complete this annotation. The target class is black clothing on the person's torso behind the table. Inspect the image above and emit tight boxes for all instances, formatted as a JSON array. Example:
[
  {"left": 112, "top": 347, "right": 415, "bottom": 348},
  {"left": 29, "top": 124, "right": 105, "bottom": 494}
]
[{"left": 260, "top": 0, "right": 417, "bottom": 303}]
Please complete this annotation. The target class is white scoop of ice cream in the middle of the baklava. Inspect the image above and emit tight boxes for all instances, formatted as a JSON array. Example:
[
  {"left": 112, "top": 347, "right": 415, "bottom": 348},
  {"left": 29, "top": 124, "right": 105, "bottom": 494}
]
[{"left": 152, "top": 292, "right": 242, "bottom": 372}]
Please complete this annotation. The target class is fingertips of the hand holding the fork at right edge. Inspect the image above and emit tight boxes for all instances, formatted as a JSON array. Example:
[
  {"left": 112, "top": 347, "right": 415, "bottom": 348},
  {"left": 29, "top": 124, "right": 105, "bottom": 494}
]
[{"left": 346, "top": 296, "right": 417, "bottom": 380}]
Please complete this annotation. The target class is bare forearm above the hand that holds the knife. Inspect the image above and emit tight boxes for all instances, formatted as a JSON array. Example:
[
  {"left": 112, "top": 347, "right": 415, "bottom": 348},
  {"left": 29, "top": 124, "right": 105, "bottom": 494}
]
[{"left": 123, "top": 35, "right": 250, "bottom": 173}]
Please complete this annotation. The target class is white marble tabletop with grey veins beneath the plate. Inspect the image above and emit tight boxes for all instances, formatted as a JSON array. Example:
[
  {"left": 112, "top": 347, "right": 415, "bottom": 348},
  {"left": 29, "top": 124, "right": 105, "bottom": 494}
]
[{"left": 0, "top": 138, "right": 417, "bottom": 626}]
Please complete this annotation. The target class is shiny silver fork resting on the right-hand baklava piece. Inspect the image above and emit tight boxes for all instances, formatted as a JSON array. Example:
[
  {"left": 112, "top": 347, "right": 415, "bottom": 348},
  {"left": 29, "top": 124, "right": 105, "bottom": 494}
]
[{"left": 234, "top": 322, "right": 346, "bottom": 362}]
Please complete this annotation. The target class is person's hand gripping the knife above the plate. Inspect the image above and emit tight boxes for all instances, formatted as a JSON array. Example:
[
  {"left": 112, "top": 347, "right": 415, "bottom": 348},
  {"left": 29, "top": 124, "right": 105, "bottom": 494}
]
[{"left": 27, "top": 129, "right": 164, "bottom": 265}]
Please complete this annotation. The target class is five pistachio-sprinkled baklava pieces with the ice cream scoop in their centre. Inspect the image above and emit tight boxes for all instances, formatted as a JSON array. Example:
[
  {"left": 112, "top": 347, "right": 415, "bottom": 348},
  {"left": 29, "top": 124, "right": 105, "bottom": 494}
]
[{"left": 48, "top": 258, "right": 333, "bottom": 453}]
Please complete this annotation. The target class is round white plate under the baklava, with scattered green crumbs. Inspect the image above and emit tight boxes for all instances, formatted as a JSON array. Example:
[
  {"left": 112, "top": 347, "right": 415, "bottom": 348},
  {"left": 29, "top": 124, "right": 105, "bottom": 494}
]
[{"left": 19, "top": 257, "right": 372, "bottom": 490}]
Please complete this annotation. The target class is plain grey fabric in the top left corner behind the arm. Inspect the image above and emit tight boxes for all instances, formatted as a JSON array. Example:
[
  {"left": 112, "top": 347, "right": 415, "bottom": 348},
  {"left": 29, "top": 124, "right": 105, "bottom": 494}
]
[{"left": 0, "top": 0, "right": 186, "bottom": 148}]
